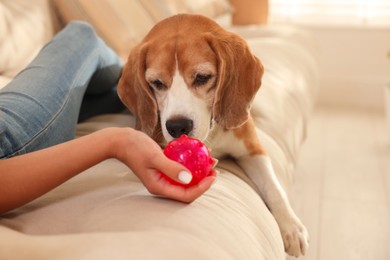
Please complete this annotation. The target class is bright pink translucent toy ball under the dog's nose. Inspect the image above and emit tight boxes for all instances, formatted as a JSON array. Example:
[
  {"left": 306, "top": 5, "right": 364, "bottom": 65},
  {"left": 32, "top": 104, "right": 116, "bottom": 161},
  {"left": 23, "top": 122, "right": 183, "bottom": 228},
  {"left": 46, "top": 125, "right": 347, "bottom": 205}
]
[{"left": 161, "top": 134, "right": 216, "bottom": 187}]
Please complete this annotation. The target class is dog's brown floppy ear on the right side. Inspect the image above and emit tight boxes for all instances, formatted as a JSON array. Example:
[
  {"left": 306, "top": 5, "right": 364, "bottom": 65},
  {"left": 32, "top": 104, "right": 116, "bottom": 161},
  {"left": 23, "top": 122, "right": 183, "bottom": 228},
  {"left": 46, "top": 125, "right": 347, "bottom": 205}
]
[{"left": 206, "top": 31, "right": 264, "bottom": 129}]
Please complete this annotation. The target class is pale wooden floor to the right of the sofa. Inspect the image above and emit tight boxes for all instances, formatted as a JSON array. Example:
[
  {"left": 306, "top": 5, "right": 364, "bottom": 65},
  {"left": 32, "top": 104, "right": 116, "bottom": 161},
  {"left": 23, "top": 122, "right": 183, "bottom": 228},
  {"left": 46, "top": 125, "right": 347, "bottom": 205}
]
[{"left": 291, "top": 107, "right": 390, "bottom": 260}]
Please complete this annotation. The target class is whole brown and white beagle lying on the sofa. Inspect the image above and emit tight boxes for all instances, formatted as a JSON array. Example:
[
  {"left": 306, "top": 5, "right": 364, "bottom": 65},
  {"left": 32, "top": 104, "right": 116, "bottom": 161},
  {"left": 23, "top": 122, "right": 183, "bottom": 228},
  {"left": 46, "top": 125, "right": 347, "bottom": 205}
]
[{"left": 118, "top": 14, "right": 308, "bottom": 256}]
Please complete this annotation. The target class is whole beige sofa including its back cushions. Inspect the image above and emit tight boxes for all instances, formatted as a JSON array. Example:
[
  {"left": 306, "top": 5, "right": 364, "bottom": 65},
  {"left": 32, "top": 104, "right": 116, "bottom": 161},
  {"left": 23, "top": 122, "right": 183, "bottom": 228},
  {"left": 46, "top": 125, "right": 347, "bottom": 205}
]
[{"left": 0, "top": 0, "right": 318, "bottom": 260}]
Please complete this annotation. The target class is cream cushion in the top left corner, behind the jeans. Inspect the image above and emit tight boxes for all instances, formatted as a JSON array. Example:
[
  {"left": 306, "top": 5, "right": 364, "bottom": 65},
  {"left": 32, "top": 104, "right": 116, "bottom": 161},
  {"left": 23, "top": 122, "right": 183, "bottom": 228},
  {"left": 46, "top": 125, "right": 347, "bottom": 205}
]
[{"left": 0, "top": 0, "right": 54, "bottom": 77}]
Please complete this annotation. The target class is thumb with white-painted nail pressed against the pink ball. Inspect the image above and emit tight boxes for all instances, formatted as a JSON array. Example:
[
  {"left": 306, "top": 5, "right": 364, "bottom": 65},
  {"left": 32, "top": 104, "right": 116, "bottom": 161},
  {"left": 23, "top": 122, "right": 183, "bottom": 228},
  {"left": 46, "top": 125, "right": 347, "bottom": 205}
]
[{"left": 156, "top": 155, "right": 192, "bottom": 184}]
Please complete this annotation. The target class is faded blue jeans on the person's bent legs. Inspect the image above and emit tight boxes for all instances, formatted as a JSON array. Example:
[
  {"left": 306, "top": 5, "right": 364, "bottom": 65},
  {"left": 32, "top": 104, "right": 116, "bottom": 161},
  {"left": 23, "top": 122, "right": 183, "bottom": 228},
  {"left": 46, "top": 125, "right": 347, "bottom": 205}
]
[{"left": 0, "top": 22, "right": 122, "bottom": 158}]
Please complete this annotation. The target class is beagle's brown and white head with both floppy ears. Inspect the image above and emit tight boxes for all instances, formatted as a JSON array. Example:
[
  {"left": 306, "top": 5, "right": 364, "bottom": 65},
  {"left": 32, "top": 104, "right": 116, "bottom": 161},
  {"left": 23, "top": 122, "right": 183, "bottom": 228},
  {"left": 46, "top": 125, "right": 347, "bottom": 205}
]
[{"left": 118, "top": 15, "right": 263, "bottom": 142}]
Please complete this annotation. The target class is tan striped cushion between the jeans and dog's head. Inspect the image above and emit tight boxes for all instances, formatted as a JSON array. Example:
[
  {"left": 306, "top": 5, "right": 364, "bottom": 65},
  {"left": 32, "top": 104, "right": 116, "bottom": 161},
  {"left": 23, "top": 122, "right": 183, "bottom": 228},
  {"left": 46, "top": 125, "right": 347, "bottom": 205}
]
[{"left": 54, "top": 0, "right": 154, "bottom": 59}]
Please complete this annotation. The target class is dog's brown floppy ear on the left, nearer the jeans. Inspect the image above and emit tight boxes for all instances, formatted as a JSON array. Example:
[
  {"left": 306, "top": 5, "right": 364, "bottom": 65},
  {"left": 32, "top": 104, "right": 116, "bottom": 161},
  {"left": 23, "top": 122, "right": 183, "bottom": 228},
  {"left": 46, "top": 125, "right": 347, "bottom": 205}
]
[{"left": 118, "top": 43, "right": 158, "bottom": 136}]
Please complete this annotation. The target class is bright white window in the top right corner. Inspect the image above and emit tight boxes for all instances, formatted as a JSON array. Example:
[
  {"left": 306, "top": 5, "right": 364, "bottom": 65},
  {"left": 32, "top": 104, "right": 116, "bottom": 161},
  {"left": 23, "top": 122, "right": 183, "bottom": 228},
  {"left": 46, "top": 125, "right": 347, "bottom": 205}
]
[{"left": 269, "top": 0, "right": 390, "bottom": 27}]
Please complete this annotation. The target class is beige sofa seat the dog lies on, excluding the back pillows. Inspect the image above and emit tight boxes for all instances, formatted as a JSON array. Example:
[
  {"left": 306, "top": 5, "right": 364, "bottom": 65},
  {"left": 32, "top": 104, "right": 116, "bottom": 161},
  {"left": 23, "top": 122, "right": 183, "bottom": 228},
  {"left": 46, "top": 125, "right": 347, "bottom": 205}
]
[{"left": 0, "top": 23, "right": 318, "bottom": 260}]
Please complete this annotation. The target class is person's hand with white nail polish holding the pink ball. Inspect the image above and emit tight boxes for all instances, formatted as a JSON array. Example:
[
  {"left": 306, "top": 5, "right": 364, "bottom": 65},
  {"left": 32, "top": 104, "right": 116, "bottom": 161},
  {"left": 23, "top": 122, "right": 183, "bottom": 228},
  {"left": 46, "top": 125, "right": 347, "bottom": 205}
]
[{"left": 114, "top": 128, "right": 216, "bottom": 203}]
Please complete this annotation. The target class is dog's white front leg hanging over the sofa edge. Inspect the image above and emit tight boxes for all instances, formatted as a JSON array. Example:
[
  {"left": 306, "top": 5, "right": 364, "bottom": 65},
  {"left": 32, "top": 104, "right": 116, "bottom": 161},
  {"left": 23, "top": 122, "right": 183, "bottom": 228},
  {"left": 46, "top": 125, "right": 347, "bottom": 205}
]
[{"left": 238, "top": 155, "right": 309, "bottom": 256}]
